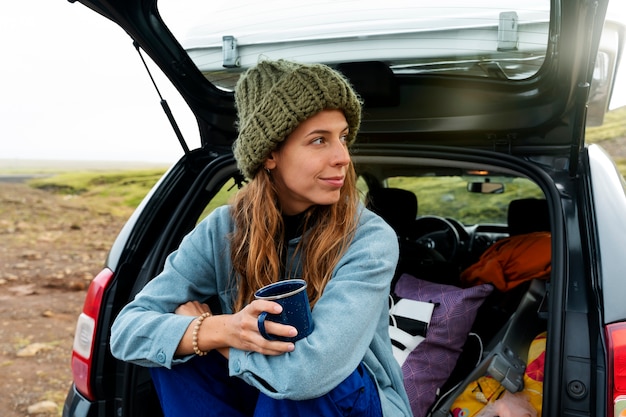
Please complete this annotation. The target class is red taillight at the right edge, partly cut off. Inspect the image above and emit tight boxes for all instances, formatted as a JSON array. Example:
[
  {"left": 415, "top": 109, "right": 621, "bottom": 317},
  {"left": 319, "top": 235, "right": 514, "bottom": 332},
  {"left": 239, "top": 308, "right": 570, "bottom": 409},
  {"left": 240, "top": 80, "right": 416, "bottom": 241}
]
[{"left": 606, "top": 322, "right": 626, "bottom": 417}]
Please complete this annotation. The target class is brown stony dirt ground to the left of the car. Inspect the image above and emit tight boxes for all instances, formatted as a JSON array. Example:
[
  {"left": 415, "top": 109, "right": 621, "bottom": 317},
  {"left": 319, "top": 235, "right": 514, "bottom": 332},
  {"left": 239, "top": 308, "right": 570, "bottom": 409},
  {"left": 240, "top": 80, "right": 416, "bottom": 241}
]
[{"left": 0, "top": 182, "right": 125, "bottom": 417}]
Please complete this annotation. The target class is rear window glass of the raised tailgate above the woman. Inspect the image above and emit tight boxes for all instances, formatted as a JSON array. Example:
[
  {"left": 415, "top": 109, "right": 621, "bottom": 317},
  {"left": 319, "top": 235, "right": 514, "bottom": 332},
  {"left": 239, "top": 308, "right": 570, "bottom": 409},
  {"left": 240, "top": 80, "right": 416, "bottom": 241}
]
[{"left": 159, "top": 0, "right": 550, "bottom": 90}]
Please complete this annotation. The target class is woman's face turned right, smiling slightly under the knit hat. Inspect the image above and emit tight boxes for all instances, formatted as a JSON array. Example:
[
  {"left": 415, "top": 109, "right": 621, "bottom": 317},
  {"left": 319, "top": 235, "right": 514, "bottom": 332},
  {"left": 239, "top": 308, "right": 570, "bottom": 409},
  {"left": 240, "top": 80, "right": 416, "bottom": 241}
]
[{"left": 265, "top": 110, "right": 350, "bottom": 215}]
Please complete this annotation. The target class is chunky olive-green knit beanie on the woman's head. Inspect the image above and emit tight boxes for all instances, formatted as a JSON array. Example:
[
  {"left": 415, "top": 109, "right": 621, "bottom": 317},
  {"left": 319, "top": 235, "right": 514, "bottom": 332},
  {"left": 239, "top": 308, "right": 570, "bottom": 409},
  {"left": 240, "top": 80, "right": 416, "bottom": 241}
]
[{"left": 233, "top": 60, "right": 361, "bottom": 178}]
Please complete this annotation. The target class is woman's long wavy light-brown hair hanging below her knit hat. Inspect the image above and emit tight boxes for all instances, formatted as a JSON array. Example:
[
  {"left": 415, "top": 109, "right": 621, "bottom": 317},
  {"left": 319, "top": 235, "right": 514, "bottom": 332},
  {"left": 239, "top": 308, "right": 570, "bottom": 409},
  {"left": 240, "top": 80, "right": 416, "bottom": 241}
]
[{"left": 230, "top": 162, "right": 359, "bottom": 311}]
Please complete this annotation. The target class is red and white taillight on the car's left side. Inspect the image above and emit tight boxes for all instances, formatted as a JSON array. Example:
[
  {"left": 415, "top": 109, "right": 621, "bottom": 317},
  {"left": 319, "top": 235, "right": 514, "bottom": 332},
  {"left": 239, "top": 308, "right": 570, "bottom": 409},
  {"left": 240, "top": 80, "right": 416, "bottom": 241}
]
[{"left": 72, "top": 269, "right": 113, "bottom": 401}]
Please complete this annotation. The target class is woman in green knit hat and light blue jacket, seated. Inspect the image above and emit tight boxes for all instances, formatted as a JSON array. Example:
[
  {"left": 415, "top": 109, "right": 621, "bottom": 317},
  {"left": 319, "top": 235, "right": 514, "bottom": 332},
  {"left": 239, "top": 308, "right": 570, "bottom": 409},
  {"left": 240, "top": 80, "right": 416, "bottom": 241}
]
[{"left": 111, "top": 60, "right": 411, "bottom": 416}]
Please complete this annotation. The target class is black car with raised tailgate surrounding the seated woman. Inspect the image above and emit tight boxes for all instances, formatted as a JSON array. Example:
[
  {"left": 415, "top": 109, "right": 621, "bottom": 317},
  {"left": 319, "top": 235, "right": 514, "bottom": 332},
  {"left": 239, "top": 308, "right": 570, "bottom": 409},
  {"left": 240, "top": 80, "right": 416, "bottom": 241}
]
[{"left": 63, "top": 0, "right": 626, "bottom": 417}]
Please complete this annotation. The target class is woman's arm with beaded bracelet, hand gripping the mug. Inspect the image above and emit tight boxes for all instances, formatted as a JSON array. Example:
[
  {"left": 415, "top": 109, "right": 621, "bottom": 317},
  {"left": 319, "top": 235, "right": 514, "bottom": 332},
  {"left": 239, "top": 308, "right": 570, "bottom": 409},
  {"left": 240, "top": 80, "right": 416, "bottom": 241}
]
[{"left": 111, "top": 207, "right": 302, "bottom": 367}]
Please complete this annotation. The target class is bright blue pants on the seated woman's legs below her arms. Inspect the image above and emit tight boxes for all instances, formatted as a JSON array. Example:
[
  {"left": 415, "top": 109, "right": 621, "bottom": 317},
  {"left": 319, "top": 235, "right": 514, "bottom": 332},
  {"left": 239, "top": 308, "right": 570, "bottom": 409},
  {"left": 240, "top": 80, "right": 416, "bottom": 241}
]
[{"left": 150, "top": 351, "right": 382, "bottom": 417}]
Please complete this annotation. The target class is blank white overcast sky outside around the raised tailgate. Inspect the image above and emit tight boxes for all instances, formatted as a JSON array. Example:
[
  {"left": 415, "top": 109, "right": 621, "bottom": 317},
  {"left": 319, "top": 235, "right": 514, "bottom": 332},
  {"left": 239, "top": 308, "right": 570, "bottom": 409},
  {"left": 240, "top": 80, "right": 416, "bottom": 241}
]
[{"left": 0, "top": 0, "right": 626, "bottom": 163}]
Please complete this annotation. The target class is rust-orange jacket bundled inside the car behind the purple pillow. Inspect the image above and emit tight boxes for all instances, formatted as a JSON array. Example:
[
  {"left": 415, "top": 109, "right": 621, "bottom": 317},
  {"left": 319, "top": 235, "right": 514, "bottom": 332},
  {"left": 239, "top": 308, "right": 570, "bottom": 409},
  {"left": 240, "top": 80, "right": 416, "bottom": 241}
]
[{"left": 461, "top": 232, "right": 551, "bottom": 291}]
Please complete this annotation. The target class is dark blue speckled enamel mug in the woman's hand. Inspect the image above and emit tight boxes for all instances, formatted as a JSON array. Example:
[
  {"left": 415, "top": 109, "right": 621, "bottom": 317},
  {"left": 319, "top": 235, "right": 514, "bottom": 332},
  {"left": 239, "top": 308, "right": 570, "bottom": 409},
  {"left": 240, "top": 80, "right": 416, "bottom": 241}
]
[{"left": 254, "top": 279, "right": 313, "bottom": 342}]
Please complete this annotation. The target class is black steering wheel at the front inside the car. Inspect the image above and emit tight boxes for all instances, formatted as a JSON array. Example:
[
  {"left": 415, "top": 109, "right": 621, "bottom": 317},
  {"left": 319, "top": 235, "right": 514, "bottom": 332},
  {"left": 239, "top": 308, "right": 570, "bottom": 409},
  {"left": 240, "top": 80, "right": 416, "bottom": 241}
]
[{"left": 414, "top": 216, "right": 460, "bottom": 262}]
